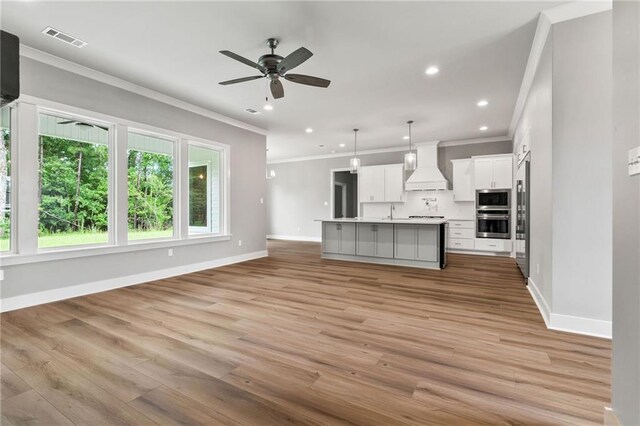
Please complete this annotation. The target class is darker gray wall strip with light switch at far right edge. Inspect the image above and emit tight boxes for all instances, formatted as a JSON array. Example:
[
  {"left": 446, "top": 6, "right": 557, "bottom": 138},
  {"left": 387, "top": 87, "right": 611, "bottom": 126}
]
[{"left": 612, "top": 0, "right": 640, "bottom": 425}]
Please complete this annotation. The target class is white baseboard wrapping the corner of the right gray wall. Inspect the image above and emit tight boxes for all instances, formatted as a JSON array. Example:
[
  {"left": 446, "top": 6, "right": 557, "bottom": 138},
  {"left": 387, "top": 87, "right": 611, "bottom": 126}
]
[{"left": 527, "top": 278, "right": 612, "bottom": 339}]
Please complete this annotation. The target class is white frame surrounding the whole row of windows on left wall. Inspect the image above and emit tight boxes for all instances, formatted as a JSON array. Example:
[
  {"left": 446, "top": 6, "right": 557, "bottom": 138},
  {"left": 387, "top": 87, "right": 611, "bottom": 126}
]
[{"left": 0, "top": 95, "right": 232, "bottom": 266}]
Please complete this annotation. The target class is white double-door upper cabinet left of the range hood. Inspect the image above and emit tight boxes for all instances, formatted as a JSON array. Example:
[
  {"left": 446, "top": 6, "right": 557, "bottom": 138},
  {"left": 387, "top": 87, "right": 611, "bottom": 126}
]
[{"left": 358, "top": 164, "right": 404, "bottom": 203}]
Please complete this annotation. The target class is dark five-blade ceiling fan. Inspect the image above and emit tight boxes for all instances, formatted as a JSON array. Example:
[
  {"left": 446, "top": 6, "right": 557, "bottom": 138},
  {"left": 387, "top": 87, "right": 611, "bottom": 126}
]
[{"left": 220, "top": 38, "right": 331, "bottom": 99}]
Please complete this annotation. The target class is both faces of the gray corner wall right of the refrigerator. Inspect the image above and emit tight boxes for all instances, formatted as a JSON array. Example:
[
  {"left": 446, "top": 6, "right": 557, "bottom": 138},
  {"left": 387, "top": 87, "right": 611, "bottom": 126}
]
[{"left": 515, "top": 12, "right": 612, "bottom": 332}]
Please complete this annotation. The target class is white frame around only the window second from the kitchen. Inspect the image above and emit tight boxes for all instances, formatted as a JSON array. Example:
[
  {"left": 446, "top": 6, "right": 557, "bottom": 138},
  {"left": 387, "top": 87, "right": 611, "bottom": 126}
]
[{"left": 124, "top": 126, "right": 180, "bottom": 245}]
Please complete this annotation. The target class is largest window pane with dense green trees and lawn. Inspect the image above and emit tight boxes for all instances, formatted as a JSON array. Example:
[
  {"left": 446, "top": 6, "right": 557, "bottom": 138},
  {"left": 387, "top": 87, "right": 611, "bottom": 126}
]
[{"left": 38, "top": 114, "right": 109, "bottom": 248}]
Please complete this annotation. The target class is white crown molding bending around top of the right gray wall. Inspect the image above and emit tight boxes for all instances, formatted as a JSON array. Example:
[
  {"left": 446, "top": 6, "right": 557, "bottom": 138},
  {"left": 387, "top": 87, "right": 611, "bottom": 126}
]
[{"left": 509, "top": 0, "right": 612, "bottom": 139}]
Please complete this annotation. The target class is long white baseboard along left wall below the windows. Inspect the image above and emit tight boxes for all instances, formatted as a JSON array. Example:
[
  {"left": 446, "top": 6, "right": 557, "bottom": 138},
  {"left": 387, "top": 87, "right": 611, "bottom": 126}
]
[{"left": 0, "top": 250, "right": 268, "bottom": 312}]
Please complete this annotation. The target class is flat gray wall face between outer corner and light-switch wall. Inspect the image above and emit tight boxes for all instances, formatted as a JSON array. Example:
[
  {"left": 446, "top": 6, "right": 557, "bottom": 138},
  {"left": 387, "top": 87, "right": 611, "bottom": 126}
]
[{"left": 552, "top": 12, "right": 612, "bottom": 321}]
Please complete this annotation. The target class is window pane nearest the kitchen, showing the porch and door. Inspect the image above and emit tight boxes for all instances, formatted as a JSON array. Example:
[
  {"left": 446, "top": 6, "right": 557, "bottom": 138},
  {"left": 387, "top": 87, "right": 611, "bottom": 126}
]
[{"left": 189, "top": 145, "right": 222, "bottom": 235}]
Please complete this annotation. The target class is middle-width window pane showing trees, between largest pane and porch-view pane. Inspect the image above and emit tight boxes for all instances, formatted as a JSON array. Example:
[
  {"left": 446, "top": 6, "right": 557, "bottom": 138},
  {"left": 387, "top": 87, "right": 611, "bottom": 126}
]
[{"left": 128, "top": 133, "right": 173, "bottom": 240}]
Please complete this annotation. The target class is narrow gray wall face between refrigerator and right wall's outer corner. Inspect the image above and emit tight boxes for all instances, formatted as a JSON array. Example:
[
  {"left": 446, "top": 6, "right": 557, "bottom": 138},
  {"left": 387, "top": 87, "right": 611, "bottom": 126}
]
[{"left": 515, "top": 34, "right": 553, "bottom": 309}]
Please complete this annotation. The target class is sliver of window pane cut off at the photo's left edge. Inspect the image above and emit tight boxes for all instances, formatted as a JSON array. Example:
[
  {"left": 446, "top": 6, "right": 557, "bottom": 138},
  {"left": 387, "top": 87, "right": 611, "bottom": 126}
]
[{"left": 0, "top": 107, "right": 11, "bottom": 251}]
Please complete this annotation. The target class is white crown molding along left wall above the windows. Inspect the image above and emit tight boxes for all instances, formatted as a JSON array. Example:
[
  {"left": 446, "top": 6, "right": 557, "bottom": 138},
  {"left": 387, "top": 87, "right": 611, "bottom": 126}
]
[{"left": 20, "top": 44, "right": 267, "bottom": 135}]
